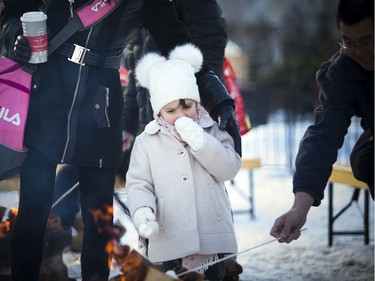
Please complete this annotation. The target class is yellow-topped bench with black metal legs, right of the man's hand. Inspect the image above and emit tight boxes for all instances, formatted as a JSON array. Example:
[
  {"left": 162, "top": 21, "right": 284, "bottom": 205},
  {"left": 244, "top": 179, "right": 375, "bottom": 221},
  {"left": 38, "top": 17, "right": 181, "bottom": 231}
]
[{"left": 328, "top": 164, "right": 369, "bottom": 246}]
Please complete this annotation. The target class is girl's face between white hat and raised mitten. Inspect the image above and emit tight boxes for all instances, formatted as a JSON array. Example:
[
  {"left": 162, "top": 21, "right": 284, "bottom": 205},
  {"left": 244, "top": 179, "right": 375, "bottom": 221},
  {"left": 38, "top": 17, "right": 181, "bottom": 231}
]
[{"left": 160, "top": 99, "right": 197, "bottom": 125}]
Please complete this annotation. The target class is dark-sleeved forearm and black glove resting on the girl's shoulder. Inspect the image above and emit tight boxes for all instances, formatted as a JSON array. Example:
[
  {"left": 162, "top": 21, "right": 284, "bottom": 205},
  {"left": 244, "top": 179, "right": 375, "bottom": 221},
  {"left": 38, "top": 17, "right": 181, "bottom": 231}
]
[{"left": 197, "top": 68, "right": 242, "bottom": 156}]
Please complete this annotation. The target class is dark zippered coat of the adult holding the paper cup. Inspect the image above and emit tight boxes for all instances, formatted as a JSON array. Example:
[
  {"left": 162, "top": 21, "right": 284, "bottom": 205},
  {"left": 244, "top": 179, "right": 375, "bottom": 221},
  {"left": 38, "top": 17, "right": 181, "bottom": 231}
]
[{"left": 0, "top": 0, "right": 142, "bottom": 167}]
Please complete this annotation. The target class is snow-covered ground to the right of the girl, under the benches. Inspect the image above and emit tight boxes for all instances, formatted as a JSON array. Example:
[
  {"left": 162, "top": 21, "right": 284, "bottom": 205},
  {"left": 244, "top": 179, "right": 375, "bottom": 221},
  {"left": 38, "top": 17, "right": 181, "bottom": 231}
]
[{"left": 228, "top": 167, "right": 374, "bottom": 281}]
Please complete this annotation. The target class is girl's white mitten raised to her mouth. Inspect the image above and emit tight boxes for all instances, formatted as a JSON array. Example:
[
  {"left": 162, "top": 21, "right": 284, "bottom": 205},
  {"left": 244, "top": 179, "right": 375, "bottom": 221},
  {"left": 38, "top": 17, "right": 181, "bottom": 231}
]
[{"left": 174, "top": 116, "right": 204, "bottom": 151}]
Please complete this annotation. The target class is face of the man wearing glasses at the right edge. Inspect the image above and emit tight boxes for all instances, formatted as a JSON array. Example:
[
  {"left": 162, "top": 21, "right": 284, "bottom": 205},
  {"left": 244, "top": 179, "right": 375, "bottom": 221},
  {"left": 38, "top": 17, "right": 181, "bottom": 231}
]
[{"left": 339, "top": 18, "right": 374, "bottom": 71}]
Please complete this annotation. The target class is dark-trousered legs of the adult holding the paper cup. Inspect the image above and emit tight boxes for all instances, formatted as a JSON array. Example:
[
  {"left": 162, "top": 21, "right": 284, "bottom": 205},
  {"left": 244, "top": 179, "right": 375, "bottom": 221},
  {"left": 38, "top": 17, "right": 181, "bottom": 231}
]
[{"left": 11, "top": 149, "right": 115, "bottom": 281}]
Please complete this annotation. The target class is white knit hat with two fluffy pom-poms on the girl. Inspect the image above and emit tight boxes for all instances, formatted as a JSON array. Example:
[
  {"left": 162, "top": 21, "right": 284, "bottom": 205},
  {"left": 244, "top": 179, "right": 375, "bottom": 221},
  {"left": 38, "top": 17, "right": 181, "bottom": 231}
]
[{"left": 135, "top": 43, "right": 203, "bottom": 114}]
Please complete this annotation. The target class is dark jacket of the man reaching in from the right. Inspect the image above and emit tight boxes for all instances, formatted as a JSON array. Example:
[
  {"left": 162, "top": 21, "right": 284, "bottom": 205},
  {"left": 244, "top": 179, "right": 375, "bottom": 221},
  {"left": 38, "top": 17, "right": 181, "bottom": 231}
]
[{"left": 293, "top": 51, "right": 374, "bottom": 205}]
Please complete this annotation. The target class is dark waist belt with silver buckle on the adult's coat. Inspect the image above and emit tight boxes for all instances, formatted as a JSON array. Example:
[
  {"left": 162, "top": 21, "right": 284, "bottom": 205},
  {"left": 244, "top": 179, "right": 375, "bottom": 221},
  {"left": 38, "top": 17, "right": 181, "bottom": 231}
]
[{"left": 57, "top": 43, "right": 121, "bottom": 69}]
